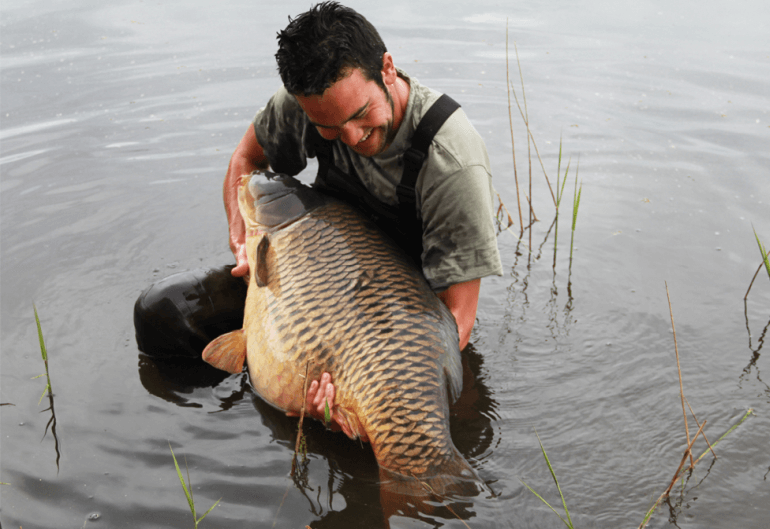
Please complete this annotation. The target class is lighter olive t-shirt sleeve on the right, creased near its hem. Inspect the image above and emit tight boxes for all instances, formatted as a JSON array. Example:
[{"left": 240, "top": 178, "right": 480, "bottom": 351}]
[{"left": 420, "top": 165, "right": 503, "bottom": 291}]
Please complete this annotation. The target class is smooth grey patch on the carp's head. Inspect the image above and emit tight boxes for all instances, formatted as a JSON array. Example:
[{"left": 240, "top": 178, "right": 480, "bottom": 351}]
[{"left": 248, "top": 170, "right": 327, "bottom": 230}]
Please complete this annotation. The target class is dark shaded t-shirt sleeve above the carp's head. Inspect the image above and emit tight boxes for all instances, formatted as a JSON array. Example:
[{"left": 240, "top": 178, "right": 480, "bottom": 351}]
[{"left": 253, "top": 87, "right": 315, "bottom": 176}]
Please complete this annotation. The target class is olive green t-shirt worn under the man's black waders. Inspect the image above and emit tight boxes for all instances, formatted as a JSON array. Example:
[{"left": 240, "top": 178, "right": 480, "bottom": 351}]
[{"left": 253, "top": 70, "right": 503, "bottom": 292}]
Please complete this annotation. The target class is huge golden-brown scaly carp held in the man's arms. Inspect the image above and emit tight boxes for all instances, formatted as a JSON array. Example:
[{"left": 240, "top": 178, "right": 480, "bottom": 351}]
[{"left": 203, "top": 172, "right": 483, "bottom": 495}]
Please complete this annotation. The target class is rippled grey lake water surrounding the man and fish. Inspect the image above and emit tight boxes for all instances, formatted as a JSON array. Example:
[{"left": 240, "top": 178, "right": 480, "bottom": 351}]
[{"left": 0, "top": 0, "right": 770, "bottom": 529}]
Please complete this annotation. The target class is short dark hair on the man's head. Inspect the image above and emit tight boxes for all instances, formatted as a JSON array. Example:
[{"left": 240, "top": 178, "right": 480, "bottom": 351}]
[{"left": 275, "top": 2, "right": 388, "bottom": 96}]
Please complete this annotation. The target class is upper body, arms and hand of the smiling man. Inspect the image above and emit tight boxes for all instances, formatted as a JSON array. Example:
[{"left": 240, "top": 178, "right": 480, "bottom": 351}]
[{"left": 137, "top": 2, "right": 502, "bottom": 424}]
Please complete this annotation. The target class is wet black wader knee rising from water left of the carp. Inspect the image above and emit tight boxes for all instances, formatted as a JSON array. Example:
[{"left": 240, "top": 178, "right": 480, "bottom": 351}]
[{"left": 134, "top": 265, "right": 247, "bottom": 358}]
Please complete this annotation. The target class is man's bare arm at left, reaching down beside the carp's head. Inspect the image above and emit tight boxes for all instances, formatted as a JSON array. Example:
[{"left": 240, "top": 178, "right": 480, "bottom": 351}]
[{"left": 223, "top": 125, "right": 268, "bottom": 277}]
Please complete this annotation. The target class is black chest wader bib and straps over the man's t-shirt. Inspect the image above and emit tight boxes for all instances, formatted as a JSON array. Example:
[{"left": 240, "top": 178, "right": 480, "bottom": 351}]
[{"left": 310, "top": 94, "right": 460, "bottom": 266}]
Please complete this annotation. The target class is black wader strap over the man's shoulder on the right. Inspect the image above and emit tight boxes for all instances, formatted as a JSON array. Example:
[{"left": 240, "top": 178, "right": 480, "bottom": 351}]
[{"left": 396, "top": 94, "right": 460, "bottom": 218}]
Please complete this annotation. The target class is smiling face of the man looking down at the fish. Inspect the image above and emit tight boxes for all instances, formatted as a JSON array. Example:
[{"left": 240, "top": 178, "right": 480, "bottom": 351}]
[{"left": 296, "top": 68, "right": 395, "bottom": 156}]
